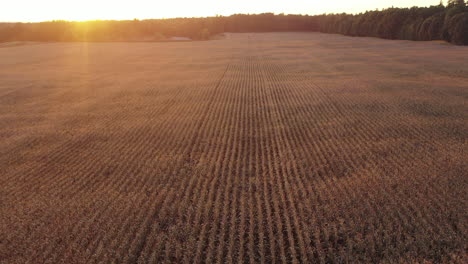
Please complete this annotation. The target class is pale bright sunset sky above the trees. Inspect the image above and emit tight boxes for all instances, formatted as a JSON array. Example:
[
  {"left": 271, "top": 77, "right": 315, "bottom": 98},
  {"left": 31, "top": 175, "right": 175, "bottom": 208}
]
[{"left": 0, "top": 0, "right": 446, "bottom": 22}]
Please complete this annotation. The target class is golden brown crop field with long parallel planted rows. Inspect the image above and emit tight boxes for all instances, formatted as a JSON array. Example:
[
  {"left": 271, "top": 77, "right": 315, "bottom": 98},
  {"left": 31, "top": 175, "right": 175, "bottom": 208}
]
[{"left": 0, "top": 33, "right": 468, "bottom": 264}]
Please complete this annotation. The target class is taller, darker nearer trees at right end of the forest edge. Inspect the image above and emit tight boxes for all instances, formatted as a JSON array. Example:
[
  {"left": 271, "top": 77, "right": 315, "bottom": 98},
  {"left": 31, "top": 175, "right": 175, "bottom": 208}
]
[{"left": 317, "top": 0, "right": 468, "bottom": 45}]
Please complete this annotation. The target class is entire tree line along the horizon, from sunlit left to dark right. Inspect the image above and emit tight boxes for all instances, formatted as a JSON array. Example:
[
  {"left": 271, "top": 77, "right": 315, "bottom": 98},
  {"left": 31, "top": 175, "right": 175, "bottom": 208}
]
[{"left": 0, "top": 0, "right": 468, "bottom": 45}]
